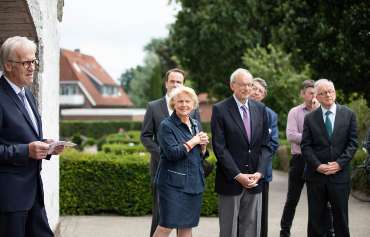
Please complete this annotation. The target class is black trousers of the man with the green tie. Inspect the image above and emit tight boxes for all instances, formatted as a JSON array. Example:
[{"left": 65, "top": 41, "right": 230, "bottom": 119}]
[{"left": 307, "top": 182, "right": 350, "bottom": 237}]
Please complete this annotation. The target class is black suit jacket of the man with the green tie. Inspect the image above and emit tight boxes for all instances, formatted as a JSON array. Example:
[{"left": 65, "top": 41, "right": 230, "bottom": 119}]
[{"left": 301, "top": 104, "right": 358, "bottom": 183}]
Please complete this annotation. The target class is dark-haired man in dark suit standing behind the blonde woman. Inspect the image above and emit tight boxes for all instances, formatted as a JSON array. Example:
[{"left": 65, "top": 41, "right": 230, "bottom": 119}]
[{"left": 140, "top": 68, "right": 200, "bottom": 236}]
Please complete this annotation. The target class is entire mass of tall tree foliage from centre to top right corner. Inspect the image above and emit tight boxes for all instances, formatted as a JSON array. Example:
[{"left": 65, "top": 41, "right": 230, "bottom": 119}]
[{"left": 170, "top": 0, "right": 370, "bottom": 102}]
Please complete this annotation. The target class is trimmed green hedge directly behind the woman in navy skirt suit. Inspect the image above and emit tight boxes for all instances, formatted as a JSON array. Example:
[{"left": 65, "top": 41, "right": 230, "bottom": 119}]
[{"left": 60, "top": 150, "right": 217, "bottom": 216}]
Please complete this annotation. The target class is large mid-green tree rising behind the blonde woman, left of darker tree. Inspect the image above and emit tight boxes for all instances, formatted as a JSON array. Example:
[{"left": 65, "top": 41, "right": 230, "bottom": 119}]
[{"left": 170, "top": 0, "right": 268, "bottom": 98}]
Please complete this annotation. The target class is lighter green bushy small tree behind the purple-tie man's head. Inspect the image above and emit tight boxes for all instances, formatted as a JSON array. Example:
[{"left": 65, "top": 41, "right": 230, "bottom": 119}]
[{"left": 243, "top": 45, "right": 311, "bottom": 128}]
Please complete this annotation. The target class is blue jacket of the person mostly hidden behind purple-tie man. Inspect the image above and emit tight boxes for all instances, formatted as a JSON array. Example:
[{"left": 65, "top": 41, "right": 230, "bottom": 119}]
[{"left": 265, "top": 106, "right": 279, "bottom": 182}]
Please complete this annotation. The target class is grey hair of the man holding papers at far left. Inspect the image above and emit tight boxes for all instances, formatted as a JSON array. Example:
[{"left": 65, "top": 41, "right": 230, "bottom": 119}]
[{"left": 0, "top": 36, "right": 37, "bottom": 71}]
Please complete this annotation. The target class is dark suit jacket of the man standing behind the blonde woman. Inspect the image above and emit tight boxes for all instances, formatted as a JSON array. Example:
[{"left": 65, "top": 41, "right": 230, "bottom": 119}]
[{"left": 140, "top": 97, "right": 200, "bottom": 177}]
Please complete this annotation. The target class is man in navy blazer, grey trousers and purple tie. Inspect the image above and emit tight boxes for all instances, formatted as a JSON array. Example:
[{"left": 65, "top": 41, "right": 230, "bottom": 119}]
[{"left": 211, "top": 68, "right": 271, "bottom": 237}]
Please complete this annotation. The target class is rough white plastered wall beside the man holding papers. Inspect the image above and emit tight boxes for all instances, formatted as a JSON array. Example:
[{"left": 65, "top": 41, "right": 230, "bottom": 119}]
[{"left": 27, "top": 0, "right": 60, "bottom": 230}]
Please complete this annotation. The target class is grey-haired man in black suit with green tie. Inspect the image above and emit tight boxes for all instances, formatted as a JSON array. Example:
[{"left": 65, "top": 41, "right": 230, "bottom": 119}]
[{"left": 301, "top": 79, "right": 357, "bottom": 237}]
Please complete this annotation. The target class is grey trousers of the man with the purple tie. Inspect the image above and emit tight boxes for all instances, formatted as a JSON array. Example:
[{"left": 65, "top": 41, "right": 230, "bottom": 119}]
[{"left": 219, "top": 189, "right": 262, "bottom": 237}]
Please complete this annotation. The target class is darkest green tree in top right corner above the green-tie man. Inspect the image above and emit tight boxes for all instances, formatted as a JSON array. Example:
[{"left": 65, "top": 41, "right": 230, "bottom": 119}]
[{"left": 274, "top": 0, "right": 370, "bottom": 102}]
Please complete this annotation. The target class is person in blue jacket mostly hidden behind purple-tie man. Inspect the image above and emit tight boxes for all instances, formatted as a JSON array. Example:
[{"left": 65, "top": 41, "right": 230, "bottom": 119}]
[{"left": 251, "top": 77, "right": 279, "bottom": 237}]
